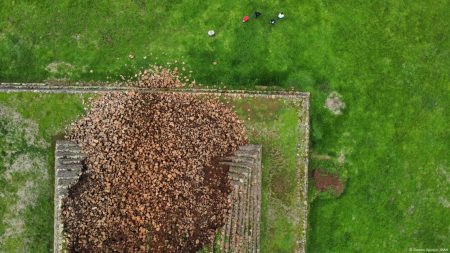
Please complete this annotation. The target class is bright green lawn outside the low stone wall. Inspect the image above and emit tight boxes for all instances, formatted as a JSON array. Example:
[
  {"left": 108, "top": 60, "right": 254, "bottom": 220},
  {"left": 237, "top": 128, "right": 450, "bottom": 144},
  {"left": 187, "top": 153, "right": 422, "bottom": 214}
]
[{"left": 0, "top": 0, "right": 450, "bottom": 252}]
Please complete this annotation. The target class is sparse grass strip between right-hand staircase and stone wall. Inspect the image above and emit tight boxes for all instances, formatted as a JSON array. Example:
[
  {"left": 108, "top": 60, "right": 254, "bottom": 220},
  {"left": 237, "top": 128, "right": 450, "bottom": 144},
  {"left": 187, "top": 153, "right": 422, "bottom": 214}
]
[{"left": 233, "top": 98, "right": 301, "bottom": 252}]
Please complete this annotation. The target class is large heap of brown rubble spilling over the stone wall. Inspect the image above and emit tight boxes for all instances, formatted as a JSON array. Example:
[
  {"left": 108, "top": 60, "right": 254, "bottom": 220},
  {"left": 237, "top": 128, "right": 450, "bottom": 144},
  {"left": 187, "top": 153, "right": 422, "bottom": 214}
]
[{"left": 62, "top": 70, "right": 247, "bottom": 252}]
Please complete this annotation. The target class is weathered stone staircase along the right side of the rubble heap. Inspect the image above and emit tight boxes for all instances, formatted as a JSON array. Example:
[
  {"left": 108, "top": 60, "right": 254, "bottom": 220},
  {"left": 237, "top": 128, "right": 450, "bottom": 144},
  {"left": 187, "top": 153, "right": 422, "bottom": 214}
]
[{"left": 213, "top": 145, "right": 262, "bottom": 253}]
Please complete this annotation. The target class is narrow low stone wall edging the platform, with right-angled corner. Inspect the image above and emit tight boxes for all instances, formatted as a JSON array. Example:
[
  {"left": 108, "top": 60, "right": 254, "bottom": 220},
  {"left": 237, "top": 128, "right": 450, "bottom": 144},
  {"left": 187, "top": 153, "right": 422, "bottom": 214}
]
[{"left": 14, "top": 83, "right": 310, "bottom": 253}]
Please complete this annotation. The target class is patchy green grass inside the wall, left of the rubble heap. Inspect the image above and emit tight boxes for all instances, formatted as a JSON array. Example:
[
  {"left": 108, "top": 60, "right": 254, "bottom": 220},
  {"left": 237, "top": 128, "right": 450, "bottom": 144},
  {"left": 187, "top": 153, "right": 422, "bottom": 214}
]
[{"left": 0, "top": 93, "right": 87, "bottom": 252}]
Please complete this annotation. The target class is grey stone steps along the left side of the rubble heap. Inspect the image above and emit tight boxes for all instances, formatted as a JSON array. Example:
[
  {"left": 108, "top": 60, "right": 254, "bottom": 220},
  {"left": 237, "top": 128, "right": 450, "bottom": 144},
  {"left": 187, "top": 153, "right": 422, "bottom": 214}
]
[{"left": 53, "top": 140, "right": 86, "bottom": 253}]
